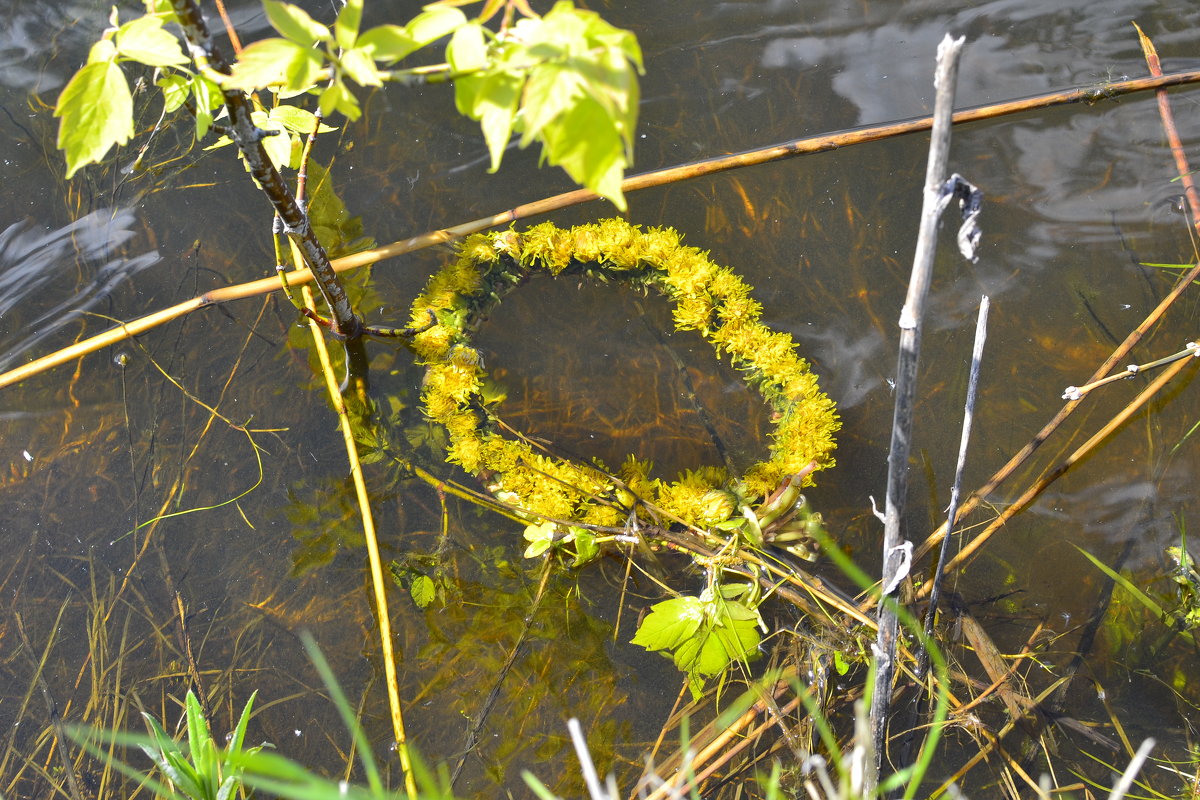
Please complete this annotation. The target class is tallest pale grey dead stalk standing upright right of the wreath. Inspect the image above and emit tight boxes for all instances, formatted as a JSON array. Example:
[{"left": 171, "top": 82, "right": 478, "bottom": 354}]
[{"left": 865, "top": 34, "right": 966, "bottom": 796}]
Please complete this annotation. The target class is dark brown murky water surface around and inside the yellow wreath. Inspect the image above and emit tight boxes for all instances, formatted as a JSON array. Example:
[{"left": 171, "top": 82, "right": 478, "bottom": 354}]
[{"left": 0, "top": 0, "right": 1200, "bottom": 796}]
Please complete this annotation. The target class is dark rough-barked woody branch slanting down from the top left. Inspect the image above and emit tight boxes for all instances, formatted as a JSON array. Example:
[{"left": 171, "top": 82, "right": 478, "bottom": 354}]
[{"left": 172, "top": 0, "right": 362, "bottom": 339}]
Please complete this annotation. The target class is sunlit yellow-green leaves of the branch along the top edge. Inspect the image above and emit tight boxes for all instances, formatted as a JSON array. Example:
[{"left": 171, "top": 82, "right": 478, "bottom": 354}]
[{"left": 55, "top": 0, "right": 642, "bottom": 210}]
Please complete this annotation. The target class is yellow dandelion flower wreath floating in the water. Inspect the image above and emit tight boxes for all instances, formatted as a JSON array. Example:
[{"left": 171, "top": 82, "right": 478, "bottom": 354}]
[{"left": 412, "top": 219, "right": 841, "bottom": 527}]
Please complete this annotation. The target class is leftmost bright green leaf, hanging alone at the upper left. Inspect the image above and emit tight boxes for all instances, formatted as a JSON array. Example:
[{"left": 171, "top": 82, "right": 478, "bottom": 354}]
[{"left": 54, "top": 61, "right": 133, "bottom": 179}]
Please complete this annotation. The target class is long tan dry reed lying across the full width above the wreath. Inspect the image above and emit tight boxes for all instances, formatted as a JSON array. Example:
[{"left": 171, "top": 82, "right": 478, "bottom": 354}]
[{"left": 0, "top": 70, "right": 1200, "bottom": 393}]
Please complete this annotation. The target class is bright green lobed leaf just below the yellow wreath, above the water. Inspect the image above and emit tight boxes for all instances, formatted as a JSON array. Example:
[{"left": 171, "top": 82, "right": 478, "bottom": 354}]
[{"left": 632, "top": 584, "right": 762, "bottom": 697}]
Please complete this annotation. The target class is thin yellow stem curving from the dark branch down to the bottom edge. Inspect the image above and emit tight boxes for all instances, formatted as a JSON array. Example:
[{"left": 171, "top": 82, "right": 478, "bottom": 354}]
[{"left": 302, "top": 287, "right": 416, "bottom": 800}]
